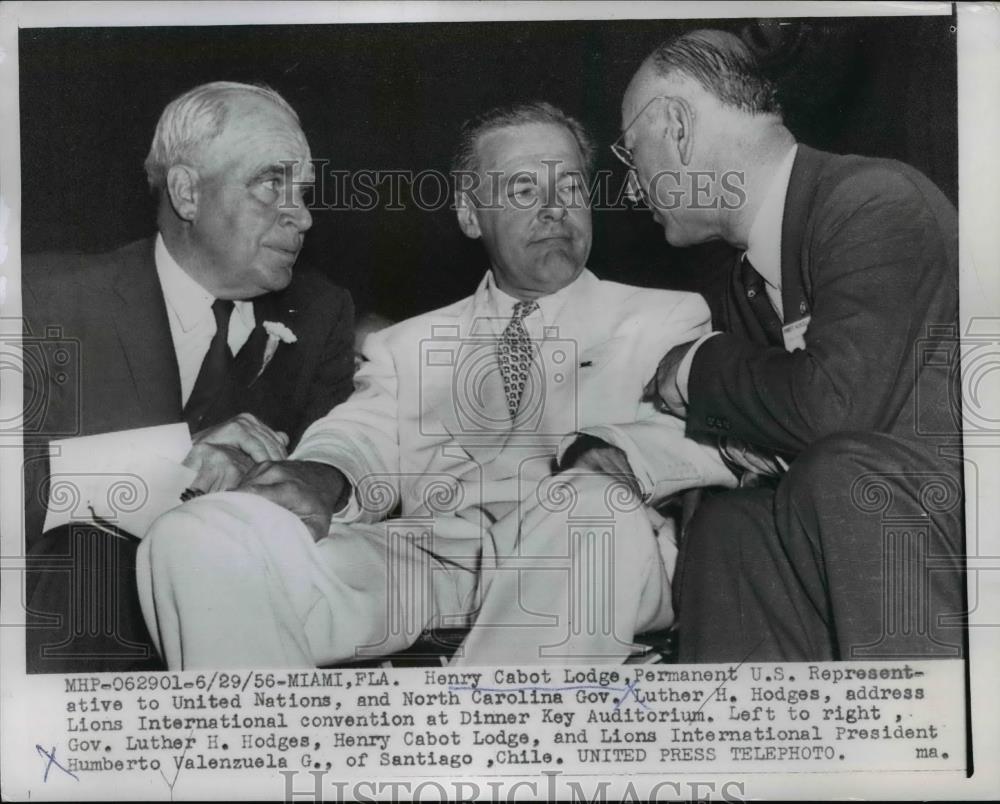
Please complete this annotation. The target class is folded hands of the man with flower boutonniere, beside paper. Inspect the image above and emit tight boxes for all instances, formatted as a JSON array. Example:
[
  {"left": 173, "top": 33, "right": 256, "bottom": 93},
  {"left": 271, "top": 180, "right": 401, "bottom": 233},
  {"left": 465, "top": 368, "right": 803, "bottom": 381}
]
[{"left": 184, "top": 413, "right": 288, "bottom": 492}]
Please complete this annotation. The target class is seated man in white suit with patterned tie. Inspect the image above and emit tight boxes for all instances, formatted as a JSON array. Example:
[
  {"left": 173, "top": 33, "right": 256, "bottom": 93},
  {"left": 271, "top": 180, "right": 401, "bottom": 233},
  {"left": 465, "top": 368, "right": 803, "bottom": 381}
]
[{"left": 138, "top": 103, "right": 735, "bottom": 669}]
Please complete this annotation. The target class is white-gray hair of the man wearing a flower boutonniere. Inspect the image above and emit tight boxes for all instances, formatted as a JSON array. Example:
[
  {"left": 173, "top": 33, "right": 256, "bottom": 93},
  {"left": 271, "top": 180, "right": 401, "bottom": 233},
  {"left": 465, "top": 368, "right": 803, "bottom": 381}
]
[{"left": 146, "top": 81, "right": 299, "bottom": 190}]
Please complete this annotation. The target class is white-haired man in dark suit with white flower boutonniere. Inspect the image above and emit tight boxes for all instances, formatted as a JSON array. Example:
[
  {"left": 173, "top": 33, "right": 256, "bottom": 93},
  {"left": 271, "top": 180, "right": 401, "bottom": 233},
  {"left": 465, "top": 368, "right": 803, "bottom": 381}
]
[{"left": 23, "top": 82, "right": 353, "bottom": 672}]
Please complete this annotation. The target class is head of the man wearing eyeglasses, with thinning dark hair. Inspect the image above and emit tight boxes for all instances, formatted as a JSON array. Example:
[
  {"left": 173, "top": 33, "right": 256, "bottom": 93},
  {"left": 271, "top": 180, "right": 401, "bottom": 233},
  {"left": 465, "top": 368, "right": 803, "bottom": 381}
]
[{"left": 621, "top": 30, "right": 795, "bottom": 246}]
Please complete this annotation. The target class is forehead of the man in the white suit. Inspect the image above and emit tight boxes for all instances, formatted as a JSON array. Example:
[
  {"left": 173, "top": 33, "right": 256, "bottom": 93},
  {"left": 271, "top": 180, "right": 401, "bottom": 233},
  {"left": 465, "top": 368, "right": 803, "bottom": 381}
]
[{"left": 477, "top": 123, "right": 584, "bottom": 181}]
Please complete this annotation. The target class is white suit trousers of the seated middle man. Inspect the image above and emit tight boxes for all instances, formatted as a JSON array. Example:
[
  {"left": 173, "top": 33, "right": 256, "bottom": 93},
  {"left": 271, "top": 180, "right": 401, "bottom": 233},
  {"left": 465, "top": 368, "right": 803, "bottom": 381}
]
[{"left": 136, "top": 473, "right": 676, "bottom": 669}]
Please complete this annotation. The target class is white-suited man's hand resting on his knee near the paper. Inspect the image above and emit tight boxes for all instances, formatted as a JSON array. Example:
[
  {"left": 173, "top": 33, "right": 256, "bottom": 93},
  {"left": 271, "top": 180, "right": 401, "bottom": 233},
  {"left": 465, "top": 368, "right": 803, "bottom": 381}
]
[{"left": 237, "top": 461, "right": 351, "bottom": 542}]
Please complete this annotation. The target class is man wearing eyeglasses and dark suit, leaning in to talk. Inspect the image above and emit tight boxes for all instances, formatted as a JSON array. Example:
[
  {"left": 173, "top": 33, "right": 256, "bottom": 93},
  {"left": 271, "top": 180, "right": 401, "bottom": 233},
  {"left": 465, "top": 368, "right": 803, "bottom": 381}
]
[{"left": 596, "top": 31, "right": 964, "bottom": 662}]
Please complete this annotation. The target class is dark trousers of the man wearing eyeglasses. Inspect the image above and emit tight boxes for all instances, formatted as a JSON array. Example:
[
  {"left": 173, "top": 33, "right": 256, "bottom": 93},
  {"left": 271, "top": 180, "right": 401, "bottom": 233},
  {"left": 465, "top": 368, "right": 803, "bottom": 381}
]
[{"left": 674, "top": 433, "right": 965, "bottom": 662}]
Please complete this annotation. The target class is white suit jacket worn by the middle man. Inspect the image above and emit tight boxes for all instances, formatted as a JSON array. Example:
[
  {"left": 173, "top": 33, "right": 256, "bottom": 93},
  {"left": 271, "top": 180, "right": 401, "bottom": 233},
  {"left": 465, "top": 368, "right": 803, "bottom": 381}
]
[{"left": 291, "top": 270, "right": 735, "bottom": 537}]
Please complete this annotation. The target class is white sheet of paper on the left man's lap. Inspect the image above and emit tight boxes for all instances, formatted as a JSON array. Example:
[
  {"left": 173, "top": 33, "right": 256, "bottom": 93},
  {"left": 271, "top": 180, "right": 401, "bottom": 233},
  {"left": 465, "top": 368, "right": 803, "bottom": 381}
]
[{"left": 45, "top": 422, "right": 195, "bottom": 538}]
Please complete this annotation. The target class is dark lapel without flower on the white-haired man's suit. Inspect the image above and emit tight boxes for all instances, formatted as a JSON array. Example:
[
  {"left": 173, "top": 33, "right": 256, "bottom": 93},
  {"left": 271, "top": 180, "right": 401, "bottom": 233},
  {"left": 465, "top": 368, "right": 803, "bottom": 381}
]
[{"left": 112, "top": 240, "right": 181, "bottom": 422}]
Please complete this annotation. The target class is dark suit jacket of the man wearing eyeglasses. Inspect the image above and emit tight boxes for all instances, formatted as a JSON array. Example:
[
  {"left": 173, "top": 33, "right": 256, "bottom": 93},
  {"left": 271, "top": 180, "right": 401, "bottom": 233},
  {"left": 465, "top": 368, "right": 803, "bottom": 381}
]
[{"left": 687, "top": 145, "right": 960, "bottom": 459}]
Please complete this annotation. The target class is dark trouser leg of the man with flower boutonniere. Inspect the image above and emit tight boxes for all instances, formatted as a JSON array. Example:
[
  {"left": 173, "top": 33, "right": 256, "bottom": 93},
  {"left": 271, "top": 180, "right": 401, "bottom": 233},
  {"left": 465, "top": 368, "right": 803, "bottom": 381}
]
[{"left": 26, "top": 523, "right": 166, "bottom": 673}]
